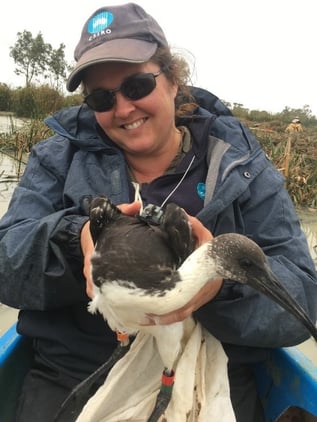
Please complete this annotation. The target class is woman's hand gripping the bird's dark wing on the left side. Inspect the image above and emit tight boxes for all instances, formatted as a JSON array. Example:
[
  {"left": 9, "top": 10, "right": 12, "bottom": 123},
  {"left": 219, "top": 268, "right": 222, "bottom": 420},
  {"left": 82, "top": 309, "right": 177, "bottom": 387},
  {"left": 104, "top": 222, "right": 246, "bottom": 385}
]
[{"left": 80, "top": 202, "right": 141, "bottom": 299}]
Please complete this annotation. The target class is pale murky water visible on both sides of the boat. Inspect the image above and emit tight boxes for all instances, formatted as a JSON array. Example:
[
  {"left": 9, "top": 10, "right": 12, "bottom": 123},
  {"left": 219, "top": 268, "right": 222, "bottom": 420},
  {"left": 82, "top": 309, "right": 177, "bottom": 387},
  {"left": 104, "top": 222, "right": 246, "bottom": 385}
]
[{"left": 0, "top": 152, "right": 317, "bottom": 364}]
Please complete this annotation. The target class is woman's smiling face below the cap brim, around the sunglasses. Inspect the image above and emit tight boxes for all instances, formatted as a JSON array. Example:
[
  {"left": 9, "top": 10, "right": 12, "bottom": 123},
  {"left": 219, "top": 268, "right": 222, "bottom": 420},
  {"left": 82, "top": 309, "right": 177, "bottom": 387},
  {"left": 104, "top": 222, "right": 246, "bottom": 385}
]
[{"left": 84, "top": 62, "right": 177, "bottom": 160}]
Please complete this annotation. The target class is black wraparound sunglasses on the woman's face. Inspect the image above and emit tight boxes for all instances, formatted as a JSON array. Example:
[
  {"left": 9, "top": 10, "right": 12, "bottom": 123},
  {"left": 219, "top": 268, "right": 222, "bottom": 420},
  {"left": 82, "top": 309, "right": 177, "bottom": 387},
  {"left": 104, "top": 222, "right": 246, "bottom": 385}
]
[{"left": 84, "top": 70, "right": 162, "bottom": 112}]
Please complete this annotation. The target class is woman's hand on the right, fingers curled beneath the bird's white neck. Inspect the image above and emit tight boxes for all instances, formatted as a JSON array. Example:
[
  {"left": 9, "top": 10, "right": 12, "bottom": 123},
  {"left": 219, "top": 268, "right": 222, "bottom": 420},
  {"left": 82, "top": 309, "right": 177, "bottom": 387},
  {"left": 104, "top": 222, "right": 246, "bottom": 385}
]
[{"left": 144, "top": 215, "right": 223, "bottom": 325}]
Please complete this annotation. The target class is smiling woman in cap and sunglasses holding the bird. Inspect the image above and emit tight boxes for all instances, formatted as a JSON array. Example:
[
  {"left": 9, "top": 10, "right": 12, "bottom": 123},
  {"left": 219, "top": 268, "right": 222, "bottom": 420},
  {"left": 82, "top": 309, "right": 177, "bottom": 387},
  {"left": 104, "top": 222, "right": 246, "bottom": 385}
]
[{"left": 0, "top": 3, "right": 317, "bottom": 422}]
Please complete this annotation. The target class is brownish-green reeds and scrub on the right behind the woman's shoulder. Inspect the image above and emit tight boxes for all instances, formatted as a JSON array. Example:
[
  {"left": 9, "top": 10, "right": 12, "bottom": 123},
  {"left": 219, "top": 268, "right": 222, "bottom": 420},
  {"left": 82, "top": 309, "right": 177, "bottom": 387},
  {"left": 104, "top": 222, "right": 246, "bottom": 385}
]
[{"left": 229, "top": 104, "right": 317, "bottom": 208}]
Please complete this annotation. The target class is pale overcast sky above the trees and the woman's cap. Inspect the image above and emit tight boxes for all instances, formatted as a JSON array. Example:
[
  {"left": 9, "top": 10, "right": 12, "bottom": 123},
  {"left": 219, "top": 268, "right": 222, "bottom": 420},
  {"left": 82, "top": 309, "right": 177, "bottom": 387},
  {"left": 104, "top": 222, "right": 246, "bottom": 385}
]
[{"left": 0, "top": 0, "right": 317, "bottom": 116}]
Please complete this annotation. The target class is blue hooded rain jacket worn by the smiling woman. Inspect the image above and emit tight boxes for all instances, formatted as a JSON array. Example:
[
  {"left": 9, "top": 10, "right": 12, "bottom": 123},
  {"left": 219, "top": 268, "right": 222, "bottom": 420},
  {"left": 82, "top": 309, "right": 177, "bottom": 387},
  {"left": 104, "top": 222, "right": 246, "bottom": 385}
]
[{"left": 0, "top": 90, "right": 317, "bottom": 379}]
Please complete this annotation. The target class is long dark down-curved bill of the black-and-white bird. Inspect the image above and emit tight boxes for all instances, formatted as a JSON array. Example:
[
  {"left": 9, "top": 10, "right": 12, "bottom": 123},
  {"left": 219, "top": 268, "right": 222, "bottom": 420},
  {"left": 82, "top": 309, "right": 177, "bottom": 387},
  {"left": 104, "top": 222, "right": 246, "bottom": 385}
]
[{"left": 248, "top": 267, "right": 317, "bottom": 341}]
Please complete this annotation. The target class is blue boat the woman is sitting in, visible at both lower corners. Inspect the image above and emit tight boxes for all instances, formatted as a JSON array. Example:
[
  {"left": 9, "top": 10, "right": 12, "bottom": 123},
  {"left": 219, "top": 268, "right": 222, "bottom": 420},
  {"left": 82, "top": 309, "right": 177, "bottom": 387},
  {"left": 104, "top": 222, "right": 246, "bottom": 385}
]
[{"left": 0, "top": 324, "right": 317, "bottom": 422}]
